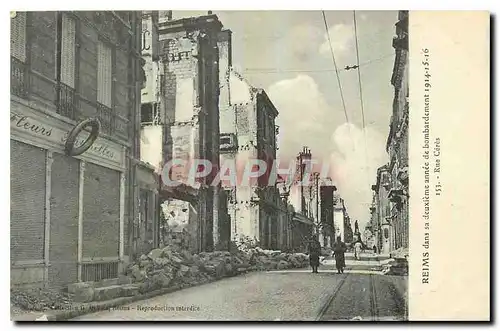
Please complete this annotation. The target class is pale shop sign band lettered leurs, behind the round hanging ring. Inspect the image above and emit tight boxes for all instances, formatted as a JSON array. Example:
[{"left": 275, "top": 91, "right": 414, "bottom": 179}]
[{"left": 10, "top": 111, "right": 121, "bottom": 163}]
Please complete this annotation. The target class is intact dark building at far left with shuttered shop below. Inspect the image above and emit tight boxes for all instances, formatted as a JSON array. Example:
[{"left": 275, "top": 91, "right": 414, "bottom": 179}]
[{"left": 10, "top": 11, "right": 146, "bottom": 287}]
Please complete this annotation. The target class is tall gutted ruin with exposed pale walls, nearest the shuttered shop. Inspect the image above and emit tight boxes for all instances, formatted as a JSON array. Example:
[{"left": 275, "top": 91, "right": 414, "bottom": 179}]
[{"left": 141, "top": 12, "right": 229, "bottom": 252}]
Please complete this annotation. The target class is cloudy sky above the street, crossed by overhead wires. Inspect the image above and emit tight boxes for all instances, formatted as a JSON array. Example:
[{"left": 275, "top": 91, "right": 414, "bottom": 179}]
[{"left": 173, "top": 11, "right": 397, "bottom": 228}]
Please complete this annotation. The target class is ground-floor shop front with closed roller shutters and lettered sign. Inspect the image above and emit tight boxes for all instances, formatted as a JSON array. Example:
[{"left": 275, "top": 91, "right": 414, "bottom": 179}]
[{"left": 10, "top": 100, "right": 127, "bottom": 286}]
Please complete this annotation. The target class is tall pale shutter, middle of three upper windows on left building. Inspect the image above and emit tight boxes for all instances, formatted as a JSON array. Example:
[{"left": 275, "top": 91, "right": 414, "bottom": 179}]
[{"left": 61, "top": 15, "right": 76, "bottom": 88}]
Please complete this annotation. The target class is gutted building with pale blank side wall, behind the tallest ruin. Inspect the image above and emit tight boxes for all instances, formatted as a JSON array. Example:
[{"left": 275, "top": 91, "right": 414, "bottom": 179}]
[{"left": 218, "top": 30, "right": 286, "bottom": 249}]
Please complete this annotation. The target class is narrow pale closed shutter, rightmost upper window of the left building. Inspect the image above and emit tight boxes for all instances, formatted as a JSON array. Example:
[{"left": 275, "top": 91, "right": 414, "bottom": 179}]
[{"left": 97, "top": 42, "right": 113, "bottom": 108}]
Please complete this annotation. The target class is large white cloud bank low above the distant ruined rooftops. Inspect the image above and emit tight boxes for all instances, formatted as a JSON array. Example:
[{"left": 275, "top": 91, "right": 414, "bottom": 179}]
[{"left": 267, "top": 75, "right": 388, "bottom": 232}]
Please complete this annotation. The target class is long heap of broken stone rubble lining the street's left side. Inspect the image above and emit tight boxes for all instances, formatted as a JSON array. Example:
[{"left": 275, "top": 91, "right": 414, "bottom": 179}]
[{"left": 126, "top": 244, "right": 308, "bottom": 293}]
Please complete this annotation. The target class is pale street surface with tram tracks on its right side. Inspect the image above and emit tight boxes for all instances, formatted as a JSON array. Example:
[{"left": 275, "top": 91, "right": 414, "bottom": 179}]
[{"left": 73, "top": 270, "right": 406, "bottom": 321}]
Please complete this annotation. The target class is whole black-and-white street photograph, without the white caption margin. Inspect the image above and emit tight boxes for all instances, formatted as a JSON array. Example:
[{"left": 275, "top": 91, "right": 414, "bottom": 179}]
[{"left": 10, "top": 10, "right": 410, "bottom": 322}]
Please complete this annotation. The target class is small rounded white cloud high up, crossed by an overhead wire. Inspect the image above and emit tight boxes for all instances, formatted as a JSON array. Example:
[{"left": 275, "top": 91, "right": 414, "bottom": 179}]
[{"left": 319, "top": 24, "right": 354, "bottom": 57}]
